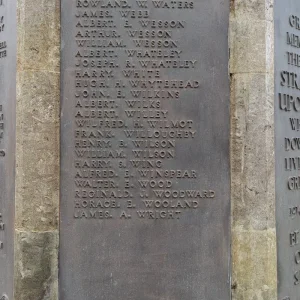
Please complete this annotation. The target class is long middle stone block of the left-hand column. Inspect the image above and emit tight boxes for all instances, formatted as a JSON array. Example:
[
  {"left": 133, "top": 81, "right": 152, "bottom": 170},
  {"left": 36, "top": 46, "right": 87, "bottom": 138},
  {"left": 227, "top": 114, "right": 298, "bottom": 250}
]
[{"left": 16, "top": 71, "right": 59, "bottom": 231}]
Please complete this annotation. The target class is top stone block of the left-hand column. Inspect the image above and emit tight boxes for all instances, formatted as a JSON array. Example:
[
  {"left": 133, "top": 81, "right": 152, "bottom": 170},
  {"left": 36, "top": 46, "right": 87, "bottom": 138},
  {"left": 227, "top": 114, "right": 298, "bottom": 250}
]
[{"left": 18, "top": 0, "right": 60, "bottom": 72}]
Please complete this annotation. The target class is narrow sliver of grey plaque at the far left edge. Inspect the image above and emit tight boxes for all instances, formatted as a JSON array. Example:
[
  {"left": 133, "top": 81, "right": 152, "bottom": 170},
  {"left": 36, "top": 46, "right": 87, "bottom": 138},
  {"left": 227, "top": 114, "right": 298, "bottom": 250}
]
[{"left": 0, "top": 0, "right": 17, "bottom": 300}]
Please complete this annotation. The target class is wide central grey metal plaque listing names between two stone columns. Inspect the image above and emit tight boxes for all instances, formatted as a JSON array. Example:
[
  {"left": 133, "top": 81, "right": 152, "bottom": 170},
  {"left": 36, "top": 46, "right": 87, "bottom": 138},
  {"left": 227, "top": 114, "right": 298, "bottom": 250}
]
[{"left": 59, "top": 0, "right": 230, "bottom": 300}]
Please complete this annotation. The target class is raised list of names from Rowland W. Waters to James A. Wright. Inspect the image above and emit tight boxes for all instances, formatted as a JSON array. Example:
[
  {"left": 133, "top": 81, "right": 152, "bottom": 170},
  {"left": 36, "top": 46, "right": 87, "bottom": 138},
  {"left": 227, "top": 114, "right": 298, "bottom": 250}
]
[{"left": 74, "top": 0, "right": 215, "bottom": 220}]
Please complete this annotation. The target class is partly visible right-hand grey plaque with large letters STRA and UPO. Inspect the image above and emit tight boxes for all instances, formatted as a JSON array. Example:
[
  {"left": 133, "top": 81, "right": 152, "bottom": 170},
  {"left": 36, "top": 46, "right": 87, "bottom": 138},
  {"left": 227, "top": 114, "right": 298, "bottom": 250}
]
[{"left": 274, "top": 0, "right": 300, "bottom": 300}]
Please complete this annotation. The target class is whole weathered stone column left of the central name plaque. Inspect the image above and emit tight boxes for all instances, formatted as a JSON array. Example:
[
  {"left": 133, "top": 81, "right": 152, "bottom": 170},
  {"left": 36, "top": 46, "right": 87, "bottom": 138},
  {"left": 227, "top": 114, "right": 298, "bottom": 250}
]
[{"left": 14, "top": 0, "right": 60, "bottom": 300}]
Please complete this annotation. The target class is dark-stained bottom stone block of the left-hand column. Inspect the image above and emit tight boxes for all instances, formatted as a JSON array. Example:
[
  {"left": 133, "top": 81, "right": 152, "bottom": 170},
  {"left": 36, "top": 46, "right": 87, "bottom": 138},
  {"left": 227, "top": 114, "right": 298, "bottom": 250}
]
[{"left": 15, "top": 231, "right": 58, "bottom": 300}]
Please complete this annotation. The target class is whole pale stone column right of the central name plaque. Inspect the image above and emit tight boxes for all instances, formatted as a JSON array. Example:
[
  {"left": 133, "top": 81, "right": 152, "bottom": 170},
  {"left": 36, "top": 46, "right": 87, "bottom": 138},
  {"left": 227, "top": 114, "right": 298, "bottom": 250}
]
[{"left": 230, "top": 0, "right": 277, "bottom": 300}]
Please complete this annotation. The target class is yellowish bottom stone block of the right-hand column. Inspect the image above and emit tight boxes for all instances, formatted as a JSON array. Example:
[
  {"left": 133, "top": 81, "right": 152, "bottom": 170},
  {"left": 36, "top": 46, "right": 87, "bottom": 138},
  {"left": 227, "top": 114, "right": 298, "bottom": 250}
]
[{"left": 232, "top": 228, "right": 277, "bottom": 300}]
